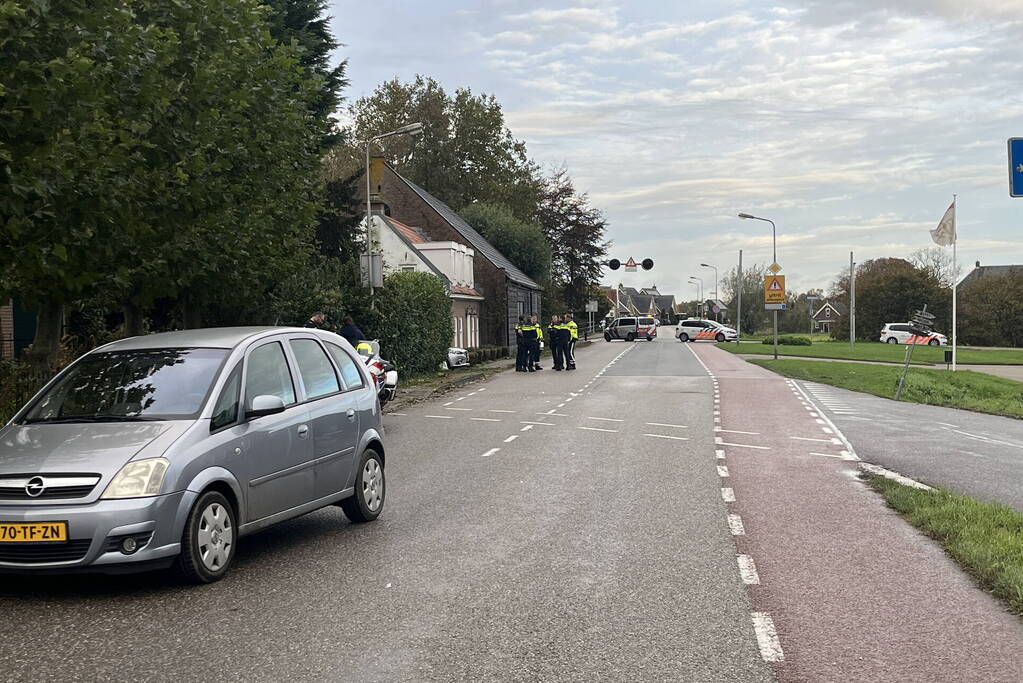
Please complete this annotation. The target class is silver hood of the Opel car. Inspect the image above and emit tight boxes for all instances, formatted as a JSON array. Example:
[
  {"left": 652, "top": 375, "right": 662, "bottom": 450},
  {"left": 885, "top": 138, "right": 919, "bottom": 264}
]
[{"left": 0, "top": 420, "right": 192, "bottom": 481}]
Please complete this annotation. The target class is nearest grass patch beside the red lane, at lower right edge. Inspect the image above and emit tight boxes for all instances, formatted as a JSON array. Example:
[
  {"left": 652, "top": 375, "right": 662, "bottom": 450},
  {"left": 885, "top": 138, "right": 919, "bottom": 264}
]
[{"left": 866, "top": 475, "right": 1023, "bottom": 616}]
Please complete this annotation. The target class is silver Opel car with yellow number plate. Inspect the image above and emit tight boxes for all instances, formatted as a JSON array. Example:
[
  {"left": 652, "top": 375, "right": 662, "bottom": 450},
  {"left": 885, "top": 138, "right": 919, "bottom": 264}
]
[{"left": 0, "top": 327, "right": 385, "bottom": 583}]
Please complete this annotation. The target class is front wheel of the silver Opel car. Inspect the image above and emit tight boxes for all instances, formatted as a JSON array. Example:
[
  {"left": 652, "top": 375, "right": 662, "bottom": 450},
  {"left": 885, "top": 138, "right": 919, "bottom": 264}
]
[{"left": 178, "top": 491, "right": 237, "bottom": 584}]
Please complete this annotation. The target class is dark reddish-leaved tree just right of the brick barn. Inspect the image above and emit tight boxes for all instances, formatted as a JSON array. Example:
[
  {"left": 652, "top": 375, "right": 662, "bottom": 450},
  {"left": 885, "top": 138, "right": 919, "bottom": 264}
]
[{"left": 536, "top": 169, "right": 611, "bottom": 311}]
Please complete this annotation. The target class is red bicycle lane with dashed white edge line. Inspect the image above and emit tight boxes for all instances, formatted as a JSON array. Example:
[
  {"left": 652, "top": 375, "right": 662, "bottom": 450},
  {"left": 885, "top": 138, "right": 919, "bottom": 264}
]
[{"left": 688, "top": 344, "right": 1023, "bottom": 681}]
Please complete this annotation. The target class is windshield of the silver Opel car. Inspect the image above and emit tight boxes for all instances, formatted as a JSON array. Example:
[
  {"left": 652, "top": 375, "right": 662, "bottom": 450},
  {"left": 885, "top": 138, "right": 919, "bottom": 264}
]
[{"left": 25, "top": 349, "right": 228, "bottom": 422}]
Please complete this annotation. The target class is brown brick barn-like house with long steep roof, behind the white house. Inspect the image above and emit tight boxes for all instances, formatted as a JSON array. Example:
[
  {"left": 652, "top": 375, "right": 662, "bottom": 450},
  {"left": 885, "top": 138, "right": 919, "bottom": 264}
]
[{"left": 360, "top": 157, "right": 542, "bottom": 347}]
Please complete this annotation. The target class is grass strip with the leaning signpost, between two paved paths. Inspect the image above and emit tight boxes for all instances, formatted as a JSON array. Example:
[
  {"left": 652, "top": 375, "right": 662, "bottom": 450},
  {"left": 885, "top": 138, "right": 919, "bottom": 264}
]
[{"left": 748, "top": 355, "right": 1023, "bottom": 417}]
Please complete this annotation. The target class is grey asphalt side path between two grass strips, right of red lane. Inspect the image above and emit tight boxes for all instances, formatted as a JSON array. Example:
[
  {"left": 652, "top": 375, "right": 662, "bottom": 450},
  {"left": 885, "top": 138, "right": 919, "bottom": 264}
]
[{"left": 797, "top": 382, "right": 1023, "bottom": 510}]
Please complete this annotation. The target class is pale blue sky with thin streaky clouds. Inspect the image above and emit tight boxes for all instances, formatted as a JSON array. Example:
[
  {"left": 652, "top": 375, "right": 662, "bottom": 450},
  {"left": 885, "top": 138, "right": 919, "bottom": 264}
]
[{"left": 329, "top": 0, "right": 1023, "bottom": 300}]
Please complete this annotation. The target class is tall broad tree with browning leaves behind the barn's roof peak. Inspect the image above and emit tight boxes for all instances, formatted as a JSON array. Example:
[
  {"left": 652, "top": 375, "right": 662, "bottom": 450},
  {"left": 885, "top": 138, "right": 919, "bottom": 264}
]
[{"left": 339, "top": 76, "right": 540, "bottom": 220}]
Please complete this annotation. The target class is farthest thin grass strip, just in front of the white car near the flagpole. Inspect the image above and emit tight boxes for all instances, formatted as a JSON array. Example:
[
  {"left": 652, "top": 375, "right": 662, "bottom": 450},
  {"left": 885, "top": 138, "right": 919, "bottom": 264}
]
[{"left": 720, "top": 336, "right": 1023, "bottom": 365}]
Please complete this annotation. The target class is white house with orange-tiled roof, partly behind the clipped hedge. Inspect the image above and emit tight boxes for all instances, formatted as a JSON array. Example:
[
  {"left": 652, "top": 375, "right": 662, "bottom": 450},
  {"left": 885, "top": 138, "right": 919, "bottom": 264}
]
[{"left": 373, "top": 213, "right": 484, "bottom": 349}]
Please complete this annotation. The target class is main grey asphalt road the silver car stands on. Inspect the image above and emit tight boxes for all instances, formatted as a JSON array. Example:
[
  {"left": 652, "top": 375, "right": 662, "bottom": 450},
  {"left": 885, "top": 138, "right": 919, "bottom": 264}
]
[{"left": 0, "top": 338, "right": 772, "bottom": 681}]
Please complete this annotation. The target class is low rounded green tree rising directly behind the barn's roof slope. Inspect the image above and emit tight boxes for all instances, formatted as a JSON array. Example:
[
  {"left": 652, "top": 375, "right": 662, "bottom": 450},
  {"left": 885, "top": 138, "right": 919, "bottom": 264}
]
[{"left": 461, "top": 203, "right": 550, "bottom": 283}]
